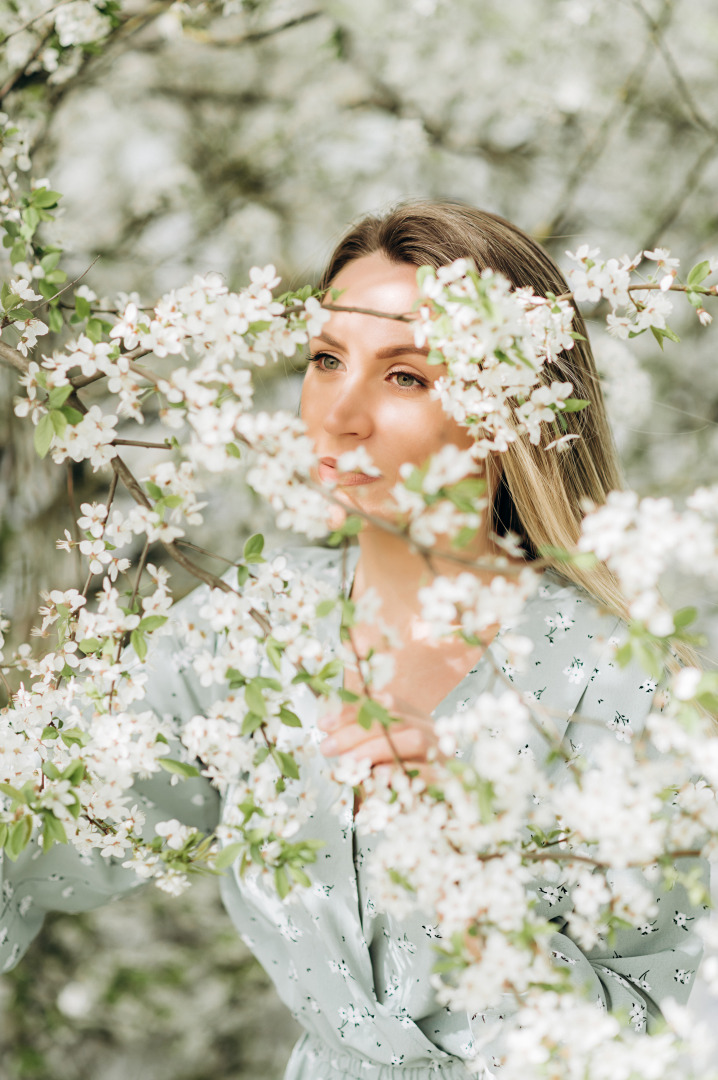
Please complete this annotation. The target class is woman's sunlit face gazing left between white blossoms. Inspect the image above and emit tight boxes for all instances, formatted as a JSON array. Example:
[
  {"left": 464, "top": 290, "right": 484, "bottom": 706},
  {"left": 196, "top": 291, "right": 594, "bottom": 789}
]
[{"left": 301, "top": 253, "right": 472, "bottom": 516}]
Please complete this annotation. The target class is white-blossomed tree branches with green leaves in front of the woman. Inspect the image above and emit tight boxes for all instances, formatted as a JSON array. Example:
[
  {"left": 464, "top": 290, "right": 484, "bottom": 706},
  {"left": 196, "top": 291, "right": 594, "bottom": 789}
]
[{"left": 0, "top": 0, "right": 718, "bottom": 1077}]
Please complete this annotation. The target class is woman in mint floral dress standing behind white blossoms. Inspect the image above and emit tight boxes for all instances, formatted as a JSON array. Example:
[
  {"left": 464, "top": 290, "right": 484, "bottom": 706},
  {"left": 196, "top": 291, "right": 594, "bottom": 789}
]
[{"left": 0, "top": 203, "right": 700, "bottom": 1080}]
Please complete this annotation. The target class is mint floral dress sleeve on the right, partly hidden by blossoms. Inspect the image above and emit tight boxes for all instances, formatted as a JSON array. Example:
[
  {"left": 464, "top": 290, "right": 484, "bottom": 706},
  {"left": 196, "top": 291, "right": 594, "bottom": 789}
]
[{"left": 472, "top": 579, "right": 708, "bottom": 1075}]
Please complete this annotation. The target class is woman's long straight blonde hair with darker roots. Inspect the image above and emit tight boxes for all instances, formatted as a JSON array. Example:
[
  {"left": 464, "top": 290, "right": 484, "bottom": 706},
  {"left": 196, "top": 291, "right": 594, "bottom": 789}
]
[{"left": 320, "top": 200, "right": 626, "bottom": 618}]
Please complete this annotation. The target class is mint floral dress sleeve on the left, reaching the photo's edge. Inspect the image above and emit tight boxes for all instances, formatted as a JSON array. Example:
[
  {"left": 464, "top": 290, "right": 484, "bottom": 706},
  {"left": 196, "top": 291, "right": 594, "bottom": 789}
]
[{"left": 0, "top": 597, "right": 219, "bottom": 971}]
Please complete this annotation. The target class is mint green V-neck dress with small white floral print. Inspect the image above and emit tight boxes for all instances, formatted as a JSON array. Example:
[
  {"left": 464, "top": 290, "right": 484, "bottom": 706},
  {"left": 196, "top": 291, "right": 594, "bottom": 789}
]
[{"left": 0, "top": 548, "right": 702, "bottom": 1080}]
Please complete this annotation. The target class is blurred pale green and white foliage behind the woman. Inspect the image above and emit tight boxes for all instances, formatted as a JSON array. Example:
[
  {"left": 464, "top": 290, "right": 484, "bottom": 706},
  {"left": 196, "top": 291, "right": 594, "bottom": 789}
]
[{"left": 0, "top": 0, "right": 718, "bottom": 1080}]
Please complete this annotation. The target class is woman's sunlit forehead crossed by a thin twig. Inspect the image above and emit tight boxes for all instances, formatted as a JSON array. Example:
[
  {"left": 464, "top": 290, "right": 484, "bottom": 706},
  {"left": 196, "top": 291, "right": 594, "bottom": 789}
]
[{"left": 325, "top": 252, "right": 419, "bottom": 343}]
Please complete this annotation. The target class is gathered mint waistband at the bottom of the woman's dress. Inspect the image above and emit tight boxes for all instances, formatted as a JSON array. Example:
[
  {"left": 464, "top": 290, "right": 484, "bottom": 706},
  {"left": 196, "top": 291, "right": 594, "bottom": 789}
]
[{"left": 284, "top": 1034, "right": 489, "bottom": 1080}]
